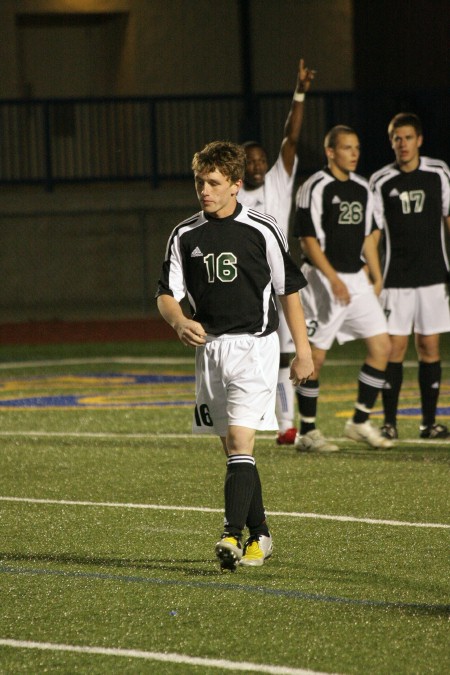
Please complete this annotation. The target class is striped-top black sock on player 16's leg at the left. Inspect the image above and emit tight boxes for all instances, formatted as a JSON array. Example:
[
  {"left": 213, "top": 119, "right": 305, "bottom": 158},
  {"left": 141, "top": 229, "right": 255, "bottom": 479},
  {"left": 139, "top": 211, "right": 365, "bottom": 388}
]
[{"left": 224, "top": 455, "right": 255, "bottom": 537}]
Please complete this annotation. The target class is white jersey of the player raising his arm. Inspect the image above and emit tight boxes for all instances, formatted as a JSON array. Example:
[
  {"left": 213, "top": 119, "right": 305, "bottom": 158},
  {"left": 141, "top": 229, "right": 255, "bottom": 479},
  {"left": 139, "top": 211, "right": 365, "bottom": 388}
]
[{"left": 238, "top": 154, "right": 298, "bottom": 237}]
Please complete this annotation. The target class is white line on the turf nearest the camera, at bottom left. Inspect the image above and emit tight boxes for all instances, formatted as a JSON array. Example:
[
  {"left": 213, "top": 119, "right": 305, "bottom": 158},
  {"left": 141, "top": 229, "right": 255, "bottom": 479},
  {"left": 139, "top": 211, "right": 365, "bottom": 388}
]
[{"left": 0, "top": 638, "right": 338, "bottom": 675}]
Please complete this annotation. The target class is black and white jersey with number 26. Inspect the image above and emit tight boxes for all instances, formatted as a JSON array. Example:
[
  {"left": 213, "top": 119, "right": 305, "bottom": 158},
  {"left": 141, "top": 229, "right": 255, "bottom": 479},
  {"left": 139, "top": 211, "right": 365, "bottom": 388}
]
[{"left": 294, "top": 168, "right": 373, "bottom": 274}]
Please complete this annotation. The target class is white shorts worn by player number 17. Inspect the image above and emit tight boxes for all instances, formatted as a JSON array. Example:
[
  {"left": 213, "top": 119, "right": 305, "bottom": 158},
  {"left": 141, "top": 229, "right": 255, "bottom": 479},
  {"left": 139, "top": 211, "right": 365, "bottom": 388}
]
[{"left": 380, "top": 284, "right": 450, "bottom": 335}]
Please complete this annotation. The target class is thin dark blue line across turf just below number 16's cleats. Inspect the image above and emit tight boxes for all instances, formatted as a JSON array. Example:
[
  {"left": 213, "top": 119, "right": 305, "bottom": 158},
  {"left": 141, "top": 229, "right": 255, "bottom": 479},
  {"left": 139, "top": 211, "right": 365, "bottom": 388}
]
[{"left": 0, "top": 565, "right": 450, "bottom": 614}]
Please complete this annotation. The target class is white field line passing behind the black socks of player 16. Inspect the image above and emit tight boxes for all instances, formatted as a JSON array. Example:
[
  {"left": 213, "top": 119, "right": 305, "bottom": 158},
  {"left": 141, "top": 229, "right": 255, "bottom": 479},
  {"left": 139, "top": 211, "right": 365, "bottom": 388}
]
[{"left": 0, "top": 496, "right": 450, "bottom": 529}]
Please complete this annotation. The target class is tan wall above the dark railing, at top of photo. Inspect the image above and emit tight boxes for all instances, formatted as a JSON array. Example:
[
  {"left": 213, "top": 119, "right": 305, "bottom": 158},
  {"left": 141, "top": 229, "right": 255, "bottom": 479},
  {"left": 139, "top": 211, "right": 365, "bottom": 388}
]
[{"left": 0, "top": 0, "right": 353, "bottom": 98}]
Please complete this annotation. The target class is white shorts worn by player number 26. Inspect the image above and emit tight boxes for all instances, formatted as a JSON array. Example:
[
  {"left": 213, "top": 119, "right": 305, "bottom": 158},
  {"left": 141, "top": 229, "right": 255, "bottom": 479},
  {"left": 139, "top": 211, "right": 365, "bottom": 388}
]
[{"left": 301, "top": 265, "right": 387, "bottom": 351}]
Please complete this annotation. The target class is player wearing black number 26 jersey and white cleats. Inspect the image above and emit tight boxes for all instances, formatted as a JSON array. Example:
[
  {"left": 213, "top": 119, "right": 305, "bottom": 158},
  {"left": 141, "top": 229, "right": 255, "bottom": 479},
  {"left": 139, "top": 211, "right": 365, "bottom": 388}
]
[{"left": 294, "top": 125, "right": 392, "bottom": 452}]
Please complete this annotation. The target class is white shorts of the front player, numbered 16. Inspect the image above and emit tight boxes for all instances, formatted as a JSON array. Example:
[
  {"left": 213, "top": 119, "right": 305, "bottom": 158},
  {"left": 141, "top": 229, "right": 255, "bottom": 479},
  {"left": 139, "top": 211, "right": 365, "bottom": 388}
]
[{"left": 192, "top": 333, "right": 280, "bottom": 436}]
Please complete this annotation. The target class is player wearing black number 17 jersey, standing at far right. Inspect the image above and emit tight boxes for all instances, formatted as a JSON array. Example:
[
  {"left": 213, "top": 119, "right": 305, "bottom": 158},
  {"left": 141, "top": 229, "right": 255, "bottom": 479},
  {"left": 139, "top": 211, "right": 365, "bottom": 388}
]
[{"left": 370, "top": 113, "right": 450, "bottom": 438}]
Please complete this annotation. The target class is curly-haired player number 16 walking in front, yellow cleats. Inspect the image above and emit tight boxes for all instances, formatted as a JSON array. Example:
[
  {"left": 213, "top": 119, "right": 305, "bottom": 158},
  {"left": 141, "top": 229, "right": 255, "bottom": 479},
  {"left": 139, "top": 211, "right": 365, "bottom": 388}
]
[{"left": 156, "top": 141, "right": 313, "bottom": 571}]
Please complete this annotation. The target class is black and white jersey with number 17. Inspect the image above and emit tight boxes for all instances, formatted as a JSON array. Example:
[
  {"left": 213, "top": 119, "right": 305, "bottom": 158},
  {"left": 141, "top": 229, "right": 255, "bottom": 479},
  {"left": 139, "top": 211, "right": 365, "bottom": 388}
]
[{"left": 370, "top": 157, "right": 450, "bottom": 288}]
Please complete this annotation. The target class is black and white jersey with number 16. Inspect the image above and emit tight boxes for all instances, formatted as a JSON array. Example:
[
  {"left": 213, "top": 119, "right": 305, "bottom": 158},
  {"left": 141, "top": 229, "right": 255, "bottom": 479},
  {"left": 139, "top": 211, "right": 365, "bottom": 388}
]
[{"left": 156, "top": 204, "right": 306, "bottom": 336}]
